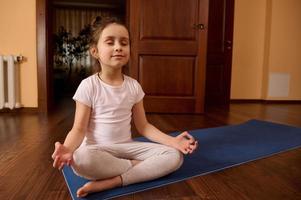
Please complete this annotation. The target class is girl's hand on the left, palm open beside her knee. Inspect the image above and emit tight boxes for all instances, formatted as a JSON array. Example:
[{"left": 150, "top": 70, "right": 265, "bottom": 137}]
[{"left": 52, "top": 142, "right": 73, "bottom": 170}]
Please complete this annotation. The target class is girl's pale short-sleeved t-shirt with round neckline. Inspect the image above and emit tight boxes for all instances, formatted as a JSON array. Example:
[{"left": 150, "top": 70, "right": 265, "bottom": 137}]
[{"left": 73, "top": 74, "right": 144, "bottom": 145}]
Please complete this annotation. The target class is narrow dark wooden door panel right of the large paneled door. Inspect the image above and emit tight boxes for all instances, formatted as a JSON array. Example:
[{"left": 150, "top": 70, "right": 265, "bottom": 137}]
[{"left": 206, "top": 0, "right": 234, "bottom": 107}]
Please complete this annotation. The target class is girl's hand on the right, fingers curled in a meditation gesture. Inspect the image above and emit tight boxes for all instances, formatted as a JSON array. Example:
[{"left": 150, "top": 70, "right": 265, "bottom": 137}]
[{"left": 174, "top": 131, "right": 198, "bottom": 154}]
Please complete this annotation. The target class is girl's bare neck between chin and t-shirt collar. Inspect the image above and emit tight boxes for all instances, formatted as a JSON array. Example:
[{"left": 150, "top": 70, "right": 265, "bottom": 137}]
[{"left": 98, "top": 69, "right": 124, "bottom": 86}]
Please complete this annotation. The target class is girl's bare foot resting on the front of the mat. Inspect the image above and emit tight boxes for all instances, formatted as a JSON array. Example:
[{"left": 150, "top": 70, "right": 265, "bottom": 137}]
[{"left": 76, "top": 176, "right": 122, "bottom": 197}]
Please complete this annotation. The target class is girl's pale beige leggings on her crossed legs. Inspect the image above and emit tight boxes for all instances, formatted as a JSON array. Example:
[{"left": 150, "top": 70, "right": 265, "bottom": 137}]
[{"left": 72, "top": 141, "right": 183, "bottom": 186}]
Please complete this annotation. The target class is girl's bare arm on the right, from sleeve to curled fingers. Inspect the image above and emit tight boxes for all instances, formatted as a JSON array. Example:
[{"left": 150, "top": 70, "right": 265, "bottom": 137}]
[{"left": 133, "top": 100, "right": 197, "bottom": 154}]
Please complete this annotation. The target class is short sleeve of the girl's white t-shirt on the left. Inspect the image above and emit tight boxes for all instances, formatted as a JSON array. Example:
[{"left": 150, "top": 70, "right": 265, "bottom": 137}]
[{"left": 73, "top": 79, "right": 93, "bottom": 107}]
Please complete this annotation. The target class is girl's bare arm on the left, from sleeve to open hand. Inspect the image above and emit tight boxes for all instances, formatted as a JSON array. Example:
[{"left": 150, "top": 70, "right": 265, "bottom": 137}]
[{"left": 52, "top": 101, "right": 91, "bottom": 169}]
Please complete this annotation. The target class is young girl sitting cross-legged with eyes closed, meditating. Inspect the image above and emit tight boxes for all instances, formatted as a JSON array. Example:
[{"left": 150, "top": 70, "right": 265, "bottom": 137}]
[{"left": 52, "top": 17, "right": 198, "bottom": 197}]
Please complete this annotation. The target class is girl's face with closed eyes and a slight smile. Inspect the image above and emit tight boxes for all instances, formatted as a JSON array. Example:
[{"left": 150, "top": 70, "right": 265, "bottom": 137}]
[{"left": 95, "top": 24, "right": 130, "bottom": 69}]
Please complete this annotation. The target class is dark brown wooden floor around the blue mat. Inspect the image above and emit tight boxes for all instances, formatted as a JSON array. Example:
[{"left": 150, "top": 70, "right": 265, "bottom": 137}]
[{"left": 0, "top": 102, "right": 301, "bottom": 200}]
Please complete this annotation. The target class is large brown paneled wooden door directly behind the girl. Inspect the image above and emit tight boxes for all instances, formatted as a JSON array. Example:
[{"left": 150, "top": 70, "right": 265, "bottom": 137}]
[{"left": 129, "top": 0, "right": 209, "bottom": 113}]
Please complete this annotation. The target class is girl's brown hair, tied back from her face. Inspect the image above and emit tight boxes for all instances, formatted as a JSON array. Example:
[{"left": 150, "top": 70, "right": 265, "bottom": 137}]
[{"left": 89, "top": 16, "right": 128, "bottom": 72}]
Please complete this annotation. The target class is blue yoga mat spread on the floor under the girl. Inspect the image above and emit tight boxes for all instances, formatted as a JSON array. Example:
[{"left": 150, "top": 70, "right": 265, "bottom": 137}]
[{"left": 63, "top": 120, "right": 301, "bottom": 200}]
